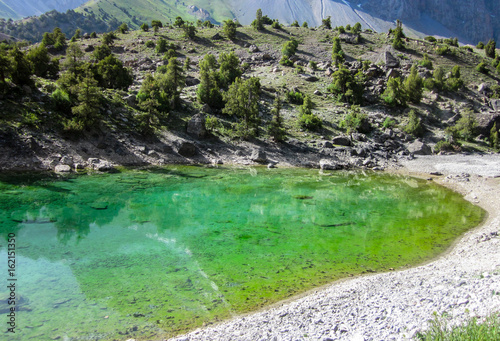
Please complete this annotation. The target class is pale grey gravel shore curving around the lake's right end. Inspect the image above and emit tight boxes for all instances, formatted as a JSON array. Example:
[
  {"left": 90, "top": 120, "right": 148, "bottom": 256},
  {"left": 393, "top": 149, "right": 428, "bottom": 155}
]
[{"left": 172, "top": 155, "right": 500, "bottom": 341}]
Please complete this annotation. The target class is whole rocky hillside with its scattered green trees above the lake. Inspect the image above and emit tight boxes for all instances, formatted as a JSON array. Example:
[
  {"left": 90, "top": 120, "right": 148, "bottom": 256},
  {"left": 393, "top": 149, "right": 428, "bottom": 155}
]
[{"left": 0, "top": 19, "right": 500, "bottom": 173}]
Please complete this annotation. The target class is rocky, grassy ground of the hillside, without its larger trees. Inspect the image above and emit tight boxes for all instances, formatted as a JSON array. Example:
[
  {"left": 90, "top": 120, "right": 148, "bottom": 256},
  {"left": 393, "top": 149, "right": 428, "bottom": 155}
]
[{"left": 0, "top": 22, "right": 500, "bottom": 173}]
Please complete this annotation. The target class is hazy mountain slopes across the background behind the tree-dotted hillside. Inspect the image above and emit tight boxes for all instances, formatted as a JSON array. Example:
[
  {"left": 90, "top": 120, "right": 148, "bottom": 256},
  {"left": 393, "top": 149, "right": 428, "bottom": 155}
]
[{"left": 0, "top": 0, "right": 500, "bottom": 44}]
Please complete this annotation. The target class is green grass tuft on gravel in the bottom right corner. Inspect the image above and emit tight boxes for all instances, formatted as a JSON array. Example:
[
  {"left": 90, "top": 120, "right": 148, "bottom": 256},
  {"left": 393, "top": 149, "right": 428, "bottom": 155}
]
[{"left": 415, "top": 314, "right": 500, "bottom": 341}]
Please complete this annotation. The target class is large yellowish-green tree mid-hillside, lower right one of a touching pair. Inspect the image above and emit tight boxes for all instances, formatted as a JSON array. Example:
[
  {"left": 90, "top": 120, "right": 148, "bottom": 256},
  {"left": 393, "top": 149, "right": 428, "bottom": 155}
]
[{"left": 222, "top": 77, "right": 260, "bottom": 138}]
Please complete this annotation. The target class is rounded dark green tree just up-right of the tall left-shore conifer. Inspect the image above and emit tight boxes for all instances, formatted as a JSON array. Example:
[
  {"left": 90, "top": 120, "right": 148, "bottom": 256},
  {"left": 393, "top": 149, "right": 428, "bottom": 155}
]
[{"left": 94, "top": 54, "right": 134, "bottom": 90}]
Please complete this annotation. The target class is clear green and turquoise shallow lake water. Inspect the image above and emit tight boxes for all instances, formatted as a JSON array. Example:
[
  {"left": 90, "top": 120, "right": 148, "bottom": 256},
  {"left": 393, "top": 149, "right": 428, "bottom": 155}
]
[{"left": 0, "top": 166, "right": 484, "bottom": 340}]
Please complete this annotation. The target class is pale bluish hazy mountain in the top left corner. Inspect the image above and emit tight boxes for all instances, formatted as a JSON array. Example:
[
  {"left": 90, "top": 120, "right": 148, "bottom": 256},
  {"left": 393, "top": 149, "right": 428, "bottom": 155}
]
[{"left": 0, "top": 0, "right": 88, "bottom": 20}]
